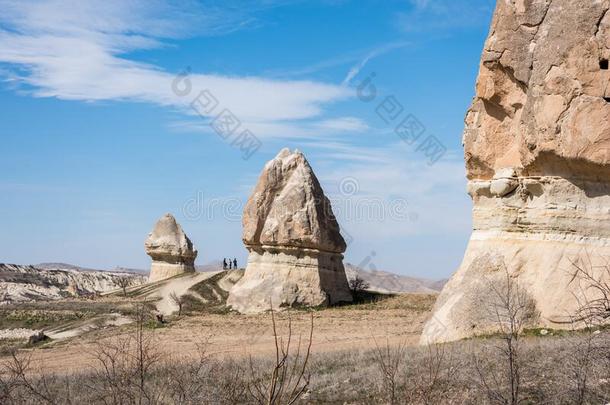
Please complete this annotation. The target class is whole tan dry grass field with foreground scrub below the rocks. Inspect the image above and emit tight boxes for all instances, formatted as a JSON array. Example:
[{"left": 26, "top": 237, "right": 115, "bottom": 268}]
[{"left": 0, "top": 288, "right": 610, "bottom": 404}]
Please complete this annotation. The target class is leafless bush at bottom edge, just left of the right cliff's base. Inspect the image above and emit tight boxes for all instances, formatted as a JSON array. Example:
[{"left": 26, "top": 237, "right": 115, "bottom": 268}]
[{"left": 373, "top": 338, "right": 406, "bottom": 404}]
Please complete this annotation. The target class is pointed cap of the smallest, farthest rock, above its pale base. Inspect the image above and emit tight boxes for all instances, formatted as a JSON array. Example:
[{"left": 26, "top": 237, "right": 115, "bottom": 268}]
[{"left": 144, "top": 214, "right": 197, "bottom": 262}]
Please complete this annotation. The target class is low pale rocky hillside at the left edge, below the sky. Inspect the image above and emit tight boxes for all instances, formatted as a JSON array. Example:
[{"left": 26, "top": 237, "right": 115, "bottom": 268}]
[{"left": 0, "top": 263, "right": 146, "bottom": 303}]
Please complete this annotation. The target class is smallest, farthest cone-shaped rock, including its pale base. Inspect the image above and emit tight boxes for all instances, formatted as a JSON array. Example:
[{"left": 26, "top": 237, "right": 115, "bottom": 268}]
[{"left": 144, "top": 214, "right": 197, "bottom": 282}]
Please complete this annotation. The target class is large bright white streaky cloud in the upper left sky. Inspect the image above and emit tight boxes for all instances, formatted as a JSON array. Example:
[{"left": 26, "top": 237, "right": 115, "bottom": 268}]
[{"left": 0, "top": 0, "right": 349, "bottom": 125}]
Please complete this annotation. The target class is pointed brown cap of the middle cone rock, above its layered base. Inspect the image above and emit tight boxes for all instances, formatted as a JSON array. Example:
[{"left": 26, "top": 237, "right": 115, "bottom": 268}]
[{"left": 243, "top": 149, "right": 346, "bottom": 253}]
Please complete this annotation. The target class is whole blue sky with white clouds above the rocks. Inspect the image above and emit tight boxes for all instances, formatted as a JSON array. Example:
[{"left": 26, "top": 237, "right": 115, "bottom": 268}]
[{"left": 0, "top": 0, "right": 495, "bottom": 278}]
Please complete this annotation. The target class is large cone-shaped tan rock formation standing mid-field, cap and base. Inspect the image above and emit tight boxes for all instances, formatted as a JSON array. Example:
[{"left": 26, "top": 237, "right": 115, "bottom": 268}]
[{"left": 227, "top": 149, "right": 352, "bottom": 313}]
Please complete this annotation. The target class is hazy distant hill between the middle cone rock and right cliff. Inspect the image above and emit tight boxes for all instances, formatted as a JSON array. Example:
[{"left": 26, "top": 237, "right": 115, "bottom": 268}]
[{"left": 345, "top": 263, "right": 447, "bottom": 293}]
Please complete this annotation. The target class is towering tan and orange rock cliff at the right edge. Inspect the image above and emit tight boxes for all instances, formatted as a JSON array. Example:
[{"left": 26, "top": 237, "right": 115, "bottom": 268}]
[{"left": 421, "top": 0, "right": 610, "bottom": 343}]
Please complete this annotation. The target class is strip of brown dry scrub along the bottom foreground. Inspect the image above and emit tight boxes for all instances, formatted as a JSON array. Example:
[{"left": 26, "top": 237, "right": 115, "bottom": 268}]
[{"left": 0, "top": 325, "right": 610, "bottom": 404}]
